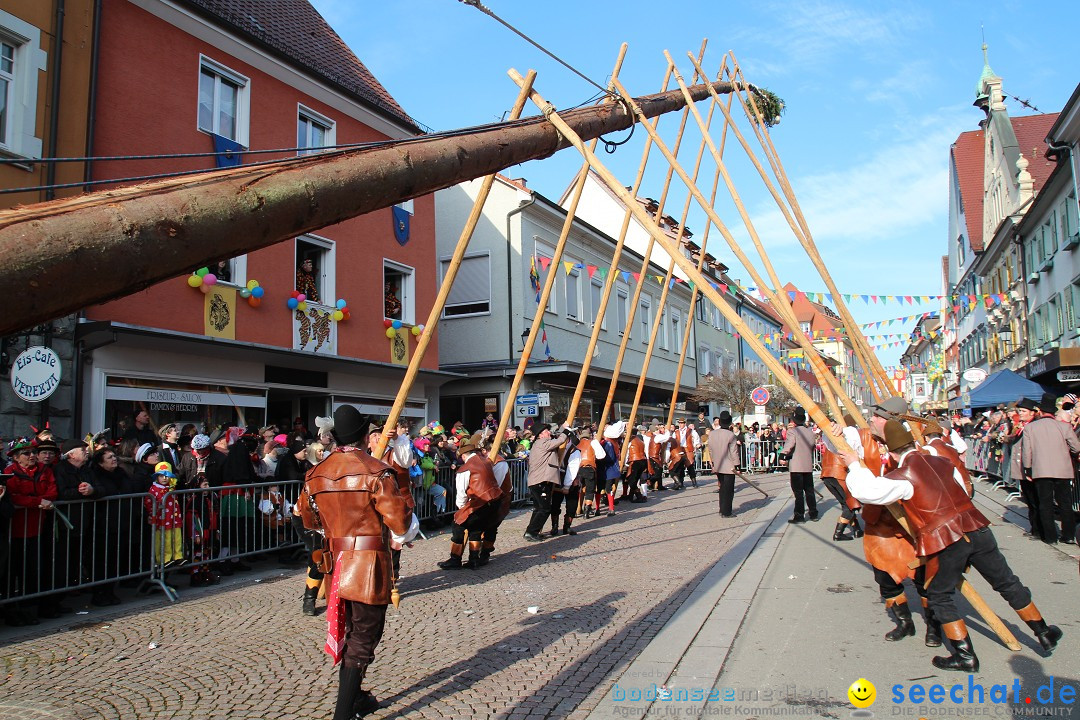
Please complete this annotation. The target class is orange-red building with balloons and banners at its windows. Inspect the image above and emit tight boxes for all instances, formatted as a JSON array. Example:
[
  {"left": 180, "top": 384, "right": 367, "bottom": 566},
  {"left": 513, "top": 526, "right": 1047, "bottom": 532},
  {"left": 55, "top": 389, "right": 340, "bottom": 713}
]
[{"left": 78, "top": 0, "right": 447, "bottom": 433}]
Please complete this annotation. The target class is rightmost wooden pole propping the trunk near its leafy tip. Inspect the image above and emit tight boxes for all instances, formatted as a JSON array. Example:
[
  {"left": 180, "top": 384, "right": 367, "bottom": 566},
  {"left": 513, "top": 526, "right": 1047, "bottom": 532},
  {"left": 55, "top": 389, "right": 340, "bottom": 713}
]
[{"left": 731, "top": 53, "right": 895, "bottom": 400}]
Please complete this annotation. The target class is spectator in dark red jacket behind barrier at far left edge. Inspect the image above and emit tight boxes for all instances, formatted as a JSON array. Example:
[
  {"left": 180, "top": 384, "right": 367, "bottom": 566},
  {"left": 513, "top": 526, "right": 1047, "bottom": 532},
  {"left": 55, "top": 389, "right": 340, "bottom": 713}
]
[{"left": 4, "top": 438, "right": 59, "bottom": 626}]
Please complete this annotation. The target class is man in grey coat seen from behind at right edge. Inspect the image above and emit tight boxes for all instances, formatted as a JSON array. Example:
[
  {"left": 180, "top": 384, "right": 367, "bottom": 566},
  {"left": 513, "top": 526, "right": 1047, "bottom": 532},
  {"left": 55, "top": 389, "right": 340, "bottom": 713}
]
[{"left": 1021, "top": 395, "right": 1080, "bottom": 545}]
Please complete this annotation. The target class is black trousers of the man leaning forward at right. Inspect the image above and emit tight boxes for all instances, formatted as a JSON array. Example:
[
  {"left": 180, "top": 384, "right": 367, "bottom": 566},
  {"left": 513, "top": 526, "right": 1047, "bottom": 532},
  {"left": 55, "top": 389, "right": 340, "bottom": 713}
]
[{"left": 927, "top": 528, "right": 1031, "bottom": 623}]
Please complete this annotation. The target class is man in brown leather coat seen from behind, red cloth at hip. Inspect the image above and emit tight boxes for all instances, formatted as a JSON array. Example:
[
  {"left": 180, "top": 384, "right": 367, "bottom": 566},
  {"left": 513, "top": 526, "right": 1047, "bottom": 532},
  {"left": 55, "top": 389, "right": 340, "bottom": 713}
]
[{"left": 297, "top": 405, "right": 419, "bottom": 720}]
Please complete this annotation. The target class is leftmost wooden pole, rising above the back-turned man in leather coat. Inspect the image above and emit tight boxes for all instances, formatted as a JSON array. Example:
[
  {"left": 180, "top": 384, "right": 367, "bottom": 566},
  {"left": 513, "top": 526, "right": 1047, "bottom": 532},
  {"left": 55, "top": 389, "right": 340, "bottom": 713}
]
[{"left": 375, "top": 70, "right": 537, "bottom": 458}]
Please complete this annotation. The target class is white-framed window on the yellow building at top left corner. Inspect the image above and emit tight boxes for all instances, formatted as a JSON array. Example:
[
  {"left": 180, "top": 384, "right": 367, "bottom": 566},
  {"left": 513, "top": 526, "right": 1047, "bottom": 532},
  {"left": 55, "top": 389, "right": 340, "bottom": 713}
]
[{"left": 0, "top": 10, "right": 49, "bottom": 158}]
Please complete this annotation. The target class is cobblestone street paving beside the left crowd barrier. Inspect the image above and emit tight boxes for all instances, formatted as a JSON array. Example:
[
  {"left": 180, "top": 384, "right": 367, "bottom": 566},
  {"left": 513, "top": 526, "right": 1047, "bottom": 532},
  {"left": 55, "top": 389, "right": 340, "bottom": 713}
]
[{"left": 0, "top": 475, "right": 787, "bottom": 720}]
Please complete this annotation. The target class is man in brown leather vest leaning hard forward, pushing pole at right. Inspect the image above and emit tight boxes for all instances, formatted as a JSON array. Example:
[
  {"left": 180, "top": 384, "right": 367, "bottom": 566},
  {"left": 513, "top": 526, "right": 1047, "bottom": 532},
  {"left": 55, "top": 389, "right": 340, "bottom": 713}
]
[{"left": 845, "top": 420, "right": 1062, "bottom": 673}]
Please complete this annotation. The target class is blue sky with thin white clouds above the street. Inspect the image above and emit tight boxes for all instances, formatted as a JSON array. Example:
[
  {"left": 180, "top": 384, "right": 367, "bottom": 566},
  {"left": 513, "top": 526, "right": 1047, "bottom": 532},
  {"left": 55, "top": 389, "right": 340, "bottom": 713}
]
[{"left": 312, "top": 0, "right": 1080, "bottom": 365}]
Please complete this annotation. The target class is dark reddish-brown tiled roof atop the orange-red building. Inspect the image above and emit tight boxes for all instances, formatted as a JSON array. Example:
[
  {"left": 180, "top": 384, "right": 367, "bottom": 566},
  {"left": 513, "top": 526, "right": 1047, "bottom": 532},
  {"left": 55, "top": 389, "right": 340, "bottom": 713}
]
[{"left": 185, "top": 0, "right": 421, "bottom": 133}]
